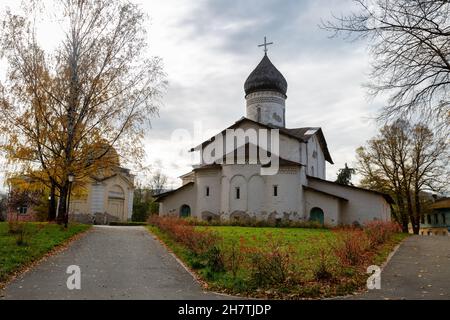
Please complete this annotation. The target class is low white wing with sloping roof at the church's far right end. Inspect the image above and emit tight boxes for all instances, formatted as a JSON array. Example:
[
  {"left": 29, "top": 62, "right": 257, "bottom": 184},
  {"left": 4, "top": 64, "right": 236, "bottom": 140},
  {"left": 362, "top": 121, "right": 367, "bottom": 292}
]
[{"left": 309, "top": 179, "right": 391, "bottom": 224}]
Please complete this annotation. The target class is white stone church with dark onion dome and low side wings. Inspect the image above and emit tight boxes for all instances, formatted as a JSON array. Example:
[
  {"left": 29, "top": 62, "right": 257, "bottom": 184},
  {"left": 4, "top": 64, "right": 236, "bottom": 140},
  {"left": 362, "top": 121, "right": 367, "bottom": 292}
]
[{"left": 157, "top": 52, "right": 392, "bottom": 226}]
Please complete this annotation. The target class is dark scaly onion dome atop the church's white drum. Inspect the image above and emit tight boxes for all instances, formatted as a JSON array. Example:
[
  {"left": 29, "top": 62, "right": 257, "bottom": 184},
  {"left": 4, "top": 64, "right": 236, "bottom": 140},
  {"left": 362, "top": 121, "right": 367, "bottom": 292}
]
[{"left": 244, "top": 55, "right": 288, "bottom": 95}]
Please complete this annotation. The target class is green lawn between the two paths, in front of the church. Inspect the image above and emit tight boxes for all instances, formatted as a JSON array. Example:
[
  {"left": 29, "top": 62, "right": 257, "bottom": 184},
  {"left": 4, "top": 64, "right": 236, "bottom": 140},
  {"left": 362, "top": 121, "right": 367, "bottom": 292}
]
[{"left": 149, "top": 226, "right": 406, "bottom": 299}]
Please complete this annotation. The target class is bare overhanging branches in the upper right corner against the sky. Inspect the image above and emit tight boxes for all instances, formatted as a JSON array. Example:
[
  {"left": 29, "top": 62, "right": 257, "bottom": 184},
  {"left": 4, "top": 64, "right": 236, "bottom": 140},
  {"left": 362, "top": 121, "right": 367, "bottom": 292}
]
[{"left": 322, "top": 0, "right": 450, "bottom": 129}]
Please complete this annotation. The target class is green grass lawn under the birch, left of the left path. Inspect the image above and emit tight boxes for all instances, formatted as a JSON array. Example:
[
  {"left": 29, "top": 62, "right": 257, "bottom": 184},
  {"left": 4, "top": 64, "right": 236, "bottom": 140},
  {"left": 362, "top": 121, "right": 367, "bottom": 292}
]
[{"left": 0, "top": 222, "right": 90, "bottom": 284}]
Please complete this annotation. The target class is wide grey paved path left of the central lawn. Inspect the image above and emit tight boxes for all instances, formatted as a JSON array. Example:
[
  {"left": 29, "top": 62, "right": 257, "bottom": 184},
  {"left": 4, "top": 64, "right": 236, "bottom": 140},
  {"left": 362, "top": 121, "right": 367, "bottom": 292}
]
[{"left": 0, "top": 227, "right": 224, "bottom": 300}]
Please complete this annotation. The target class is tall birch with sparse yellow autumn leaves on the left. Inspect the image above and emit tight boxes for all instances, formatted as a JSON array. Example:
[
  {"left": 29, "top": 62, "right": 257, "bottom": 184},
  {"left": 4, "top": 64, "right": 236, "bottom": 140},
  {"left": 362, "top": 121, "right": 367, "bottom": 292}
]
[{"left": 0, "top": 0, "right": 165, "bottom": 225}]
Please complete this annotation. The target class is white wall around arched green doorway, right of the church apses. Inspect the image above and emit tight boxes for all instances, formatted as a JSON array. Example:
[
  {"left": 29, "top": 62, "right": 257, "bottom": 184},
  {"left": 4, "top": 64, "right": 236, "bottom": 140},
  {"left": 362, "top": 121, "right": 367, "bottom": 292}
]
[{"left": 304, "top": 190, "right": 341, "bottom": 227}]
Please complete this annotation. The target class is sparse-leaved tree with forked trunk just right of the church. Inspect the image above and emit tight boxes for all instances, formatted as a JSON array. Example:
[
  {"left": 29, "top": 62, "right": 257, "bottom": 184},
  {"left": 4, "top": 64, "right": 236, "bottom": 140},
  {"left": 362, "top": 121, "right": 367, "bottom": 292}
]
[{"left": 357, "top": 120, "right": 449, "bottom": 234}]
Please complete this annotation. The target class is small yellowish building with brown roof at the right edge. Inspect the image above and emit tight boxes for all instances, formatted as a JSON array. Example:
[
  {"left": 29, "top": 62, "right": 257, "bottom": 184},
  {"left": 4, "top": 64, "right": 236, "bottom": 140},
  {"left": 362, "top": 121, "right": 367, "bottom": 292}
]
[{"left": 420, "top": 198, "right": 450, "bottom": 236}]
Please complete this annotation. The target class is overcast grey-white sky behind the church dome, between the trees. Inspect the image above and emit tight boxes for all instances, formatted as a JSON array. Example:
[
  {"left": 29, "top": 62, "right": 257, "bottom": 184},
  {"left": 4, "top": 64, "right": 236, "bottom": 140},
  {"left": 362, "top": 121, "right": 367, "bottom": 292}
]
[{"left": 0, "top": 0, "right": 381, "bottom": 187}]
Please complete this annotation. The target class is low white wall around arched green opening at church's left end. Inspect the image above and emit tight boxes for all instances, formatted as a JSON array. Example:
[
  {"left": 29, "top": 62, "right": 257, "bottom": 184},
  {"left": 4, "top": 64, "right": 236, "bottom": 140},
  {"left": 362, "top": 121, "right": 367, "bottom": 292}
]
[{"left": 159, "top": 185, "right": 200, "bottom": 218}]
